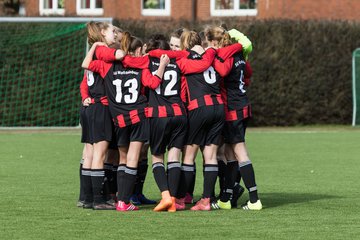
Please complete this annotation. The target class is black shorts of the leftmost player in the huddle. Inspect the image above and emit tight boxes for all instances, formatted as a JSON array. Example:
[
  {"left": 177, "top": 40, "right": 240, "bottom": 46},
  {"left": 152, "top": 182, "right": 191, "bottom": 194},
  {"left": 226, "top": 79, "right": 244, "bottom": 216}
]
[{"left": 86, "top": 103, "right": 113, "bottom": 143}]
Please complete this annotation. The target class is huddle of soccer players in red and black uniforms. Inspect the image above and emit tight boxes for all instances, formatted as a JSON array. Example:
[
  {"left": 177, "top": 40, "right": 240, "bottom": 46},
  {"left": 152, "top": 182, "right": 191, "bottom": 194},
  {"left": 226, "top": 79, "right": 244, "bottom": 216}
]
[{"left": 78, "top": 22, "right": 262, "bottom": 212}]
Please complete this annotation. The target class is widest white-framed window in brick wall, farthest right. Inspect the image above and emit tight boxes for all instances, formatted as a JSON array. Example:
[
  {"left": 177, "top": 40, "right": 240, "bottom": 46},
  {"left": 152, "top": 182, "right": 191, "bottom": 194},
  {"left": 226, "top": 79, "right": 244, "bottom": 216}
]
[{"left": 210, "top": 0, "right": 257, "bottom": 16}]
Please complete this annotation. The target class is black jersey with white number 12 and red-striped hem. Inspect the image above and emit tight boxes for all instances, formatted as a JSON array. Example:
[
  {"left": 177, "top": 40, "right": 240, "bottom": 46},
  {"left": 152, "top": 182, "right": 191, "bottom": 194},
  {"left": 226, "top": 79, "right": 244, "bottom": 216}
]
[{"left": 148, "top": 57, "right": 186, "bottom": 117}]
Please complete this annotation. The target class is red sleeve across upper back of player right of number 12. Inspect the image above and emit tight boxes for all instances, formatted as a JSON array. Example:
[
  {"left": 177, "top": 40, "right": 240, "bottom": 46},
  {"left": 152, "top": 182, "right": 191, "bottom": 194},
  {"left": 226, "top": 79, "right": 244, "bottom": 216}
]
[{"left": 176, "top": 48, "right": 216, "bottom": 74}]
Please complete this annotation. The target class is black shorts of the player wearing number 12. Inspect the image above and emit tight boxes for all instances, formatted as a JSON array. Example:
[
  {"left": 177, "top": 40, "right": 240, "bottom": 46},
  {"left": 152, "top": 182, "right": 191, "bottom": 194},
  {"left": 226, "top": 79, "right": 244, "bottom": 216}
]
[{"left": 150, "top": 116, "right": 187, "bottom": 155}]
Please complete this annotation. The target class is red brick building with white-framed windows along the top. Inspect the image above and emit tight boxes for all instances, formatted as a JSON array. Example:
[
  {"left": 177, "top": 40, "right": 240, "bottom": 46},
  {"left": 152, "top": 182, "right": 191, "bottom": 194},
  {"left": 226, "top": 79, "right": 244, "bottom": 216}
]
[{"left": 0, "top": 0, "right": 360, "bottom": 21}]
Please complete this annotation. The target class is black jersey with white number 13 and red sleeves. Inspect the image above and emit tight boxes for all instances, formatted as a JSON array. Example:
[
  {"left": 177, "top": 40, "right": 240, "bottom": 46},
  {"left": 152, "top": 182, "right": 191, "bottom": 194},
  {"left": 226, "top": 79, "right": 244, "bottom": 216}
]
[{"left": 89, "top": 60, "right": 161, "bottom": 127}]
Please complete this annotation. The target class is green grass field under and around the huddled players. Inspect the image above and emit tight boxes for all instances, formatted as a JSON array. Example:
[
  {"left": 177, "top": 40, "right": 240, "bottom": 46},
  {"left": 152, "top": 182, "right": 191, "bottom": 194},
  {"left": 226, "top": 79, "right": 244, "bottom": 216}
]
[{"left": 0, "top": 127, "right": 360, "bottom": 240}]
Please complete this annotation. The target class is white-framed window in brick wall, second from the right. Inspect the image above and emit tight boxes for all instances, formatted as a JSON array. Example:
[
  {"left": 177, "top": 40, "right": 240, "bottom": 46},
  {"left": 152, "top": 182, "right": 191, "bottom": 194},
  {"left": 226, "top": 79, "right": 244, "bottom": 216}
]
[{"left": 141, "top": 0, "right": 170, "bottom": 16}]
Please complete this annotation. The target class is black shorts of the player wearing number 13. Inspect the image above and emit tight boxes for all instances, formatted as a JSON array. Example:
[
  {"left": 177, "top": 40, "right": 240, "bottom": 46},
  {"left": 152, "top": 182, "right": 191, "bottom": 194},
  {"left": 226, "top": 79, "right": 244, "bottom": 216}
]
[{"left": 115, "top": 119, "right": 149, "bottom": 147}]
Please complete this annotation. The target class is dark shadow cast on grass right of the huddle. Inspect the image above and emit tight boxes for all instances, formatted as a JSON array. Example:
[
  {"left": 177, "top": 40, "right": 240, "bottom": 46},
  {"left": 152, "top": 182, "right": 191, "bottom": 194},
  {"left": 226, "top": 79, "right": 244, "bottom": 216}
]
[{"left": 259, "top": 192, "right": 341, "bottom": 208}]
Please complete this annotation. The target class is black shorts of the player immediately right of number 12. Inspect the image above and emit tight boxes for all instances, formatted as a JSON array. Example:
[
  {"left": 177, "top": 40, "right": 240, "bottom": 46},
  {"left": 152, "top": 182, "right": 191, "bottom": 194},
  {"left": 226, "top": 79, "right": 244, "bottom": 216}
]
[{"left": 186, "top": 105, "right": 225, "bottom": 147}]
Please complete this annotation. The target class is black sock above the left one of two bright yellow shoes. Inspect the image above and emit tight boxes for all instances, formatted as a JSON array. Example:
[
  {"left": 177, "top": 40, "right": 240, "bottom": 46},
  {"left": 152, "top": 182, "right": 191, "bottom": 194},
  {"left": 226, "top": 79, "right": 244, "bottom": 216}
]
[{"left": 220, "top": 160, "right": 238, "bottom": 202}]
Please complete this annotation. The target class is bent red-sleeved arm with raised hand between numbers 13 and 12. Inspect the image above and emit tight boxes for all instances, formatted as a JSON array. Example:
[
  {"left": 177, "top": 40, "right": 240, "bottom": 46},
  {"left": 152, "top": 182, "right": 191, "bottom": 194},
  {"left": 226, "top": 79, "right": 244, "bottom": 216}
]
[{"left": 141, "top": 54, "right": 170, "bottom": 89}]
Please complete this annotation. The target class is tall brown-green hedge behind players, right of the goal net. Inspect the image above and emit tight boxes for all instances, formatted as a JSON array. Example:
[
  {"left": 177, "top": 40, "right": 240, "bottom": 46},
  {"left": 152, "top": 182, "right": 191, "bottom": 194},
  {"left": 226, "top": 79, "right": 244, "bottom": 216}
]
[{"left": 115, "top": 18, "right": 360, "bottom": 126}]
